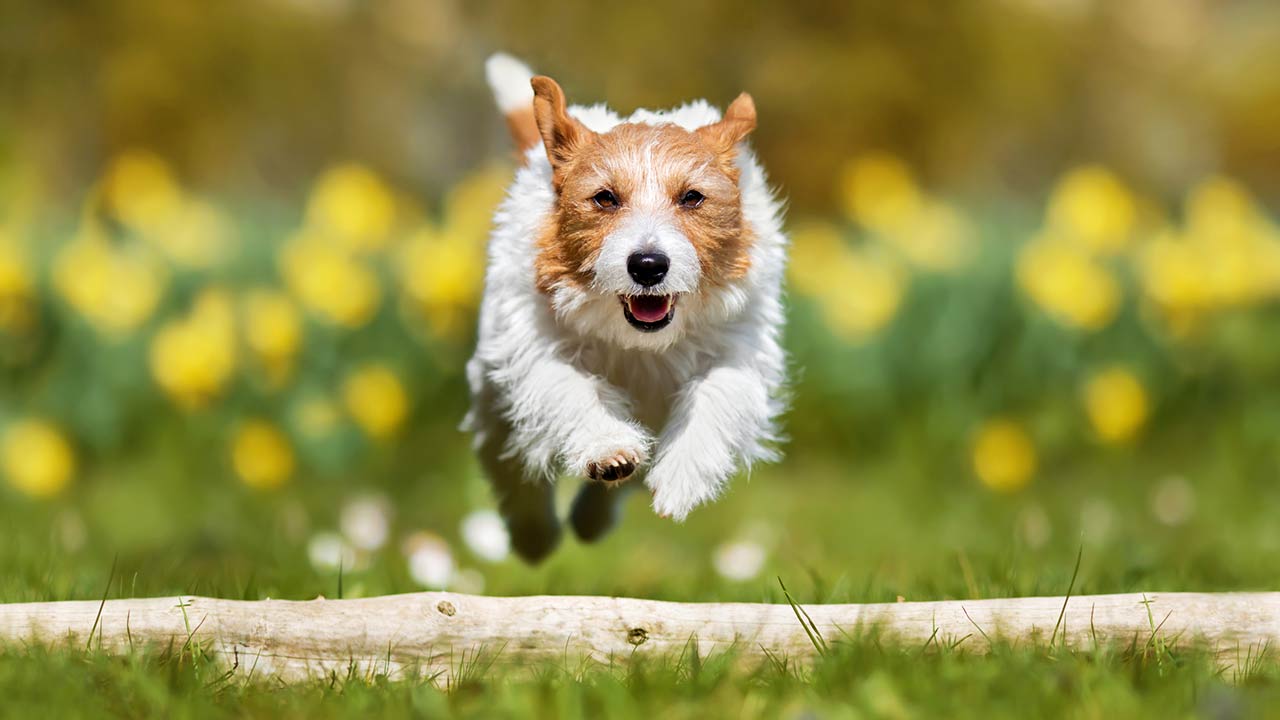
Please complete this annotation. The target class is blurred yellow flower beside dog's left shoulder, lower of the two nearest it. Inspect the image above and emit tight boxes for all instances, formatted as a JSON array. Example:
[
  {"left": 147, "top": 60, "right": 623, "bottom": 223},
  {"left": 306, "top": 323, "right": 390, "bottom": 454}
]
[{"left": 398, "top": 227, "right": 484, "bottom": 336}]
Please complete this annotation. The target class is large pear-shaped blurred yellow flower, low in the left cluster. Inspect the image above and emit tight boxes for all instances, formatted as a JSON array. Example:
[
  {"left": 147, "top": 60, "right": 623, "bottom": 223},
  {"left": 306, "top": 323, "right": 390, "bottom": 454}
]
[{"left": 151, "top": 290, "right": 236, "bottom": 410}]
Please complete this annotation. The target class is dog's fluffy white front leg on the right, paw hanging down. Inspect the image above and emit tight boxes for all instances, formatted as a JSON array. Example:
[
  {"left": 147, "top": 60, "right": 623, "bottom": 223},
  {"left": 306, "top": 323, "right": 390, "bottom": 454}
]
[{"left": 645, "top": 366, "right": 774, "bottom": 521}]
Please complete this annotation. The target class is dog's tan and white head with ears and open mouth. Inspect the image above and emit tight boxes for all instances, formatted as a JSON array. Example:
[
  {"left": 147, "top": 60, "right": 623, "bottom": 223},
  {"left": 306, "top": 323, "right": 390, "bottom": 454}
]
[{"left": 532, "top": 77, "right": 755, "bottom": 350}]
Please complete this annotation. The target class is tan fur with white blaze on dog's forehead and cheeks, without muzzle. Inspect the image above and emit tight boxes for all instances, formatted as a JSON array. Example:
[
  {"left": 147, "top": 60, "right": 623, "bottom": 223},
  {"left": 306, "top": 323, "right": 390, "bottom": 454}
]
[{"left": 535, "top": 119, "right": 754, "bottom": 292}]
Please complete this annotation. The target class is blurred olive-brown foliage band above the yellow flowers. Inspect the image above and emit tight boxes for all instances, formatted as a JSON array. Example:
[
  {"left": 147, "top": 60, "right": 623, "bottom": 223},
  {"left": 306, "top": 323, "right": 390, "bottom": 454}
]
[{"left": 0, "top": 0, "right": 1280, "bottom": 211}]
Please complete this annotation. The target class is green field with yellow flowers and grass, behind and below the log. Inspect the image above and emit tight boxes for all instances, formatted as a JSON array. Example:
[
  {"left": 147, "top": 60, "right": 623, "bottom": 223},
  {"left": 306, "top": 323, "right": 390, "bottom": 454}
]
[{"left": 0, "top": 152, "right": 1280, "bottom": 717}]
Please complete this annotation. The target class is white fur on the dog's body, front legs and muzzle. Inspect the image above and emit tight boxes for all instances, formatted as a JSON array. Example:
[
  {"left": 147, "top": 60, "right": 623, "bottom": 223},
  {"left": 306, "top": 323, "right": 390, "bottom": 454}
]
[{"left": 465, "top": 59, "right": 787, "bottom": 532}]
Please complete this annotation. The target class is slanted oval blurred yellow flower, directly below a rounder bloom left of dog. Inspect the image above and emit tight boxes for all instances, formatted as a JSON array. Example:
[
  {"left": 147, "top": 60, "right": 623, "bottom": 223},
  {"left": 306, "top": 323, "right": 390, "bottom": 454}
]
[{"left": 280, "top": 233, "right": 381, "bottom": 328}]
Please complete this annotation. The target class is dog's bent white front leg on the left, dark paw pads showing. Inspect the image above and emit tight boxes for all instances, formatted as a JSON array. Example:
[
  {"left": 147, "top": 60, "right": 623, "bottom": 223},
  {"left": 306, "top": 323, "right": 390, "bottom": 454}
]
[{"left": 507, "top": 355, "right": 652, "bottom": 480}]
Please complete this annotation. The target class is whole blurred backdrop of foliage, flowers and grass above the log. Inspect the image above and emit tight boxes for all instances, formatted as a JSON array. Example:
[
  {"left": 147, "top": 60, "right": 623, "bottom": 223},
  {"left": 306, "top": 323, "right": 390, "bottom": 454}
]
[{"left": 0, "top": 0, "right": 1280, "bottom": 601}]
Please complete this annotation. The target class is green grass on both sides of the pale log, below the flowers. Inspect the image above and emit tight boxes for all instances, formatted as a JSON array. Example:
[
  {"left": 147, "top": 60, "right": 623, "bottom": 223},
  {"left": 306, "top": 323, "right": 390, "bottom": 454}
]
[{"left": 0, "top": 404, "right": 1280, "bottom": 717}]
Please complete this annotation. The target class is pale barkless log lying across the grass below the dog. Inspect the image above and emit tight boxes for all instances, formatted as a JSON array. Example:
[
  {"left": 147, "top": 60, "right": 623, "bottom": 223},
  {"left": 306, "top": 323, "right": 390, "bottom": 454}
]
[{"left": 0, "top": 592, "right": 1280, "bottom": 682}]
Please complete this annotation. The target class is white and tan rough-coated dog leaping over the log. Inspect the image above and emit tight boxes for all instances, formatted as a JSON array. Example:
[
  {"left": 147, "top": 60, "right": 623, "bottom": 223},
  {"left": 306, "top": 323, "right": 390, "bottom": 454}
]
[{"left": 463, "top": 54, "right": 787, "bottom": 562}]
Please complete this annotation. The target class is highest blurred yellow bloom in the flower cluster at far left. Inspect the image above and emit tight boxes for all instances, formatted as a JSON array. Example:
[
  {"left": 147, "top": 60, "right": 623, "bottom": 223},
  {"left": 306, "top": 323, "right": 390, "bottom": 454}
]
[{"left": 101, "top": 150, "right": 183, "bottom": 233}]
